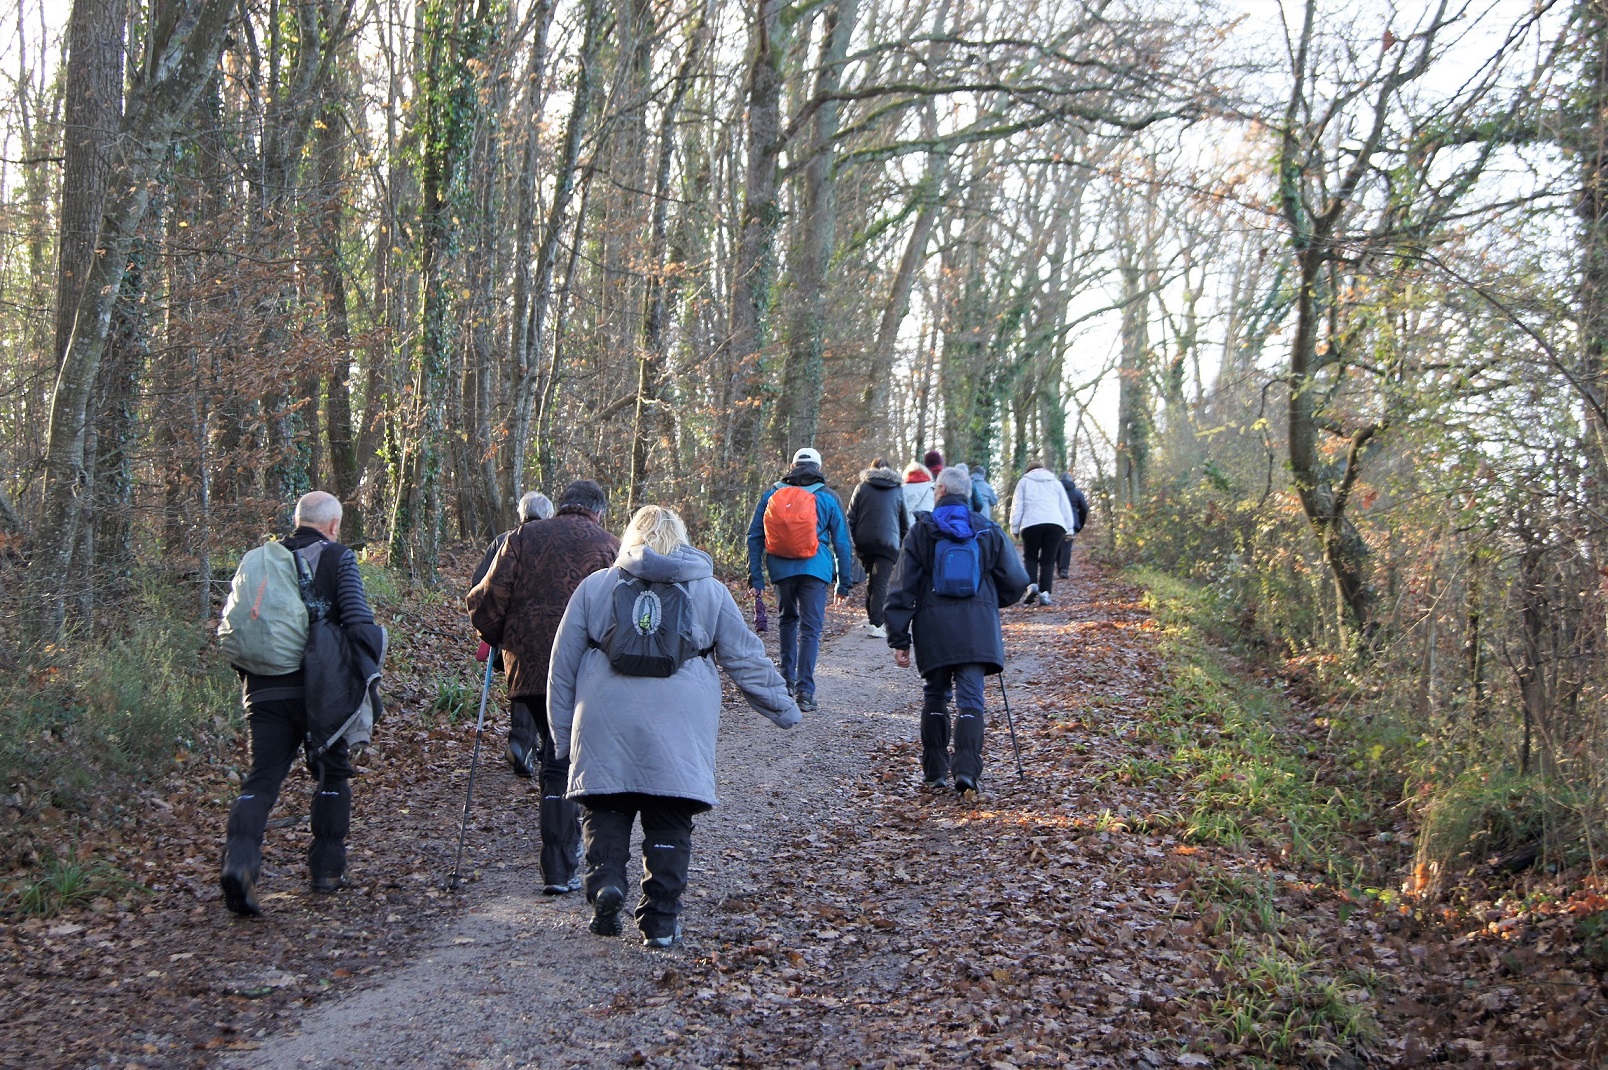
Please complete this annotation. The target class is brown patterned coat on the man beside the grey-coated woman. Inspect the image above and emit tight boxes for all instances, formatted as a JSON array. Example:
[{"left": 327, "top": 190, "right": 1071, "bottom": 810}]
[{"left": 468, "top": 508, "right": 619, "bottom": 698}]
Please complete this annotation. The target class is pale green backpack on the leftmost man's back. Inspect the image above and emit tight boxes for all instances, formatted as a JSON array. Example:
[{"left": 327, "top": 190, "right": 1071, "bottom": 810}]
[{"left": 217, "top": 539, "right": 323, "bottom": 676}]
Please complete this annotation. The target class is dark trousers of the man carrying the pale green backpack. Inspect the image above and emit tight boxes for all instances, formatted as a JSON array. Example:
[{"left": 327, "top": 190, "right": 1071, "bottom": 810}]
[{"left": 224, "top": 698, "right": 352, "bottom": 880}]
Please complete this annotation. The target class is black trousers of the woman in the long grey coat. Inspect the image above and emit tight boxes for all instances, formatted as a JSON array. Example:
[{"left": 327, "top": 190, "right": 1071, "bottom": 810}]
[{"left": 580, "top": 792, "right": 709, "bottom": 936}]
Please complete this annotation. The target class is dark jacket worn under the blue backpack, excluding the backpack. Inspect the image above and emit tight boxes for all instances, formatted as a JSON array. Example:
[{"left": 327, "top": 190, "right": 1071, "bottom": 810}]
[{"left": 884, "top": 494, "right": 1028, "bottom": 676}]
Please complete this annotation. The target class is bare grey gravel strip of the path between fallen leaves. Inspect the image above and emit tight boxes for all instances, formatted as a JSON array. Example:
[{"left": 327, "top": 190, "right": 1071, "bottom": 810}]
[{"left": 220, "top": 614, "right": 920, "bottom": 1070}]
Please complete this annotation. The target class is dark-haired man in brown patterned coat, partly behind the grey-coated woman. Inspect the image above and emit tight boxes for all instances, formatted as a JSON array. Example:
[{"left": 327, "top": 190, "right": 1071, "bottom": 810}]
[{"left": 468, "top": 479, "right": 619, "bottom": 895}]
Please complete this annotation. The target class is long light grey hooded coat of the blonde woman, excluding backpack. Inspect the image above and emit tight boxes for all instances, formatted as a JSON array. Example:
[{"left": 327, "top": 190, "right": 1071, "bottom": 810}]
[{"left": 547, "top": 545, "right": 799, "bottom": 806}]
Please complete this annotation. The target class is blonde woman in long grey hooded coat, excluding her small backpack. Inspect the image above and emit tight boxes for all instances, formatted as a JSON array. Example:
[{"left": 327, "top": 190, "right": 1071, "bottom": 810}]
[{"left": 547, "top": 505, "right": 799, "bottom": 948}]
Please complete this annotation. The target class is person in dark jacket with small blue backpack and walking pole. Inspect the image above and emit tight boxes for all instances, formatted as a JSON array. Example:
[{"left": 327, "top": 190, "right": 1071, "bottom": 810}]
[{"left": 886, "top": 468, "right": 1028, "bottom": 792}]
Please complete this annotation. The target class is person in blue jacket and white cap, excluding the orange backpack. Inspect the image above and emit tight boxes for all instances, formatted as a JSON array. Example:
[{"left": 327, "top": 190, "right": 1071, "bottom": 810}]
[{"left": 748, "top": 446, "right": 854, "bottom": 713}]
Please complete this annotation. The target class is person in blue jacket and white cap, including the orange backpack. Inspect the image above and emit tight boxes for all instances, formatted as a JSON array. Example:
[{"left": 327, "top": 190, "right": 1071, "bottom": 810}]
[{"left": 748, "top": 446, "right": 854, "bottom": 713}]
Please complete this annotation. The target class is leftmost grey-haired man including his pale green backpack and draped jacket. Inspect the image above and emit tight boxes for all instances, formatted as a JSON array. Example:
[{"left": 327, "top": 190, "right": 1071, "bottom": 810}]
[{"left": 219, "top": 491, "right": 386, "bottom": 916}]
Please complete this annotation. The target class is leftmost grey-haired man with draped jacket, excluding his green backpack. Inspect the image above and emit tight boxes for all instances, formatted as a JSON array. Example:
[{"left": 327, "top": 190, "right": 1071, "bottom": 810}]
[{"left": 219, "top": 491, "right": 384, "bottom": 916}]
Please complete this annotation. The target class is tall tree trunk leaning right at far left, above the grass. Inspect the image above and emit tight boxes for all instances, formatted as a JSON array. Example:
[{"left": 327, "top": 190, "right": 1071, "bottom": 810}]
[{"left": 31, "top": 0, "right": 236, "bottom": 639}]
